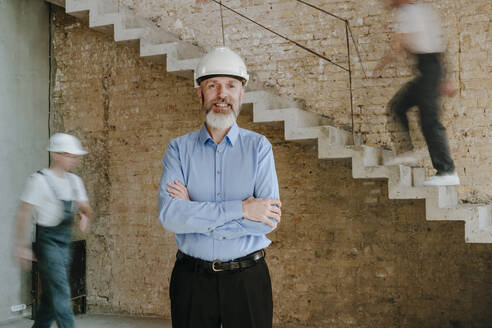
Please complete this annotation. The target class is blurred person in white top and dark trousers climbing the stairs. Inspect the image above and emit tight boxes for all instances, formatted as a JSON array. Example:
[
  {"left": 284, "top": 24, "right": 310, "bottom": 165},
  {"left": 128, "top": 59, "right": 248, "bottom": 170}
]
[{"left": 374, "top": 0, "right": 460, "bottom": 186}]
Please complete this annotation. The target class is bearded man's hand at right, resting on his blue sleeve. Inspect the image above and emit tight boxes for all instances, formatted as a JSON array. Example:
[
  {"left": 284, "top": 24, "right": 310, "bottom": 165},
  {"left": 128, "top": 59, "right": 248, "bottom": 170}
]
[{"left": 242, "top": 197, "right": 282, "bottom": 228}]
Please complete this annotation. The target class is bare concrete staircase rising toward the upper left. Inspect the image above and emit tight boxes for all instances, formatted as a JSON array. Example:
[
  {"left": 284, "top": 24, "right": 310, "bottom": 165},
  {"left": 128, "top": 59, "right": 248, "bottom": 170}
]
[{"left": 45, "top": 0, "right": 492, "bottom": 243}]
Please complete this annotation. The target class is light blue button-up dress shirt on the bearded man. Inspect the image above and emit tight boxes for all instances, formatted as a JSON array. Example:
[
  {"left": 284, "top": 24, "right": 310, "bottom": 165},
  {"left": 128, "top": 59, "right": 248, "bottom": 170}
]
[{"left": 159, "top": 124, "right": 279, "bottom": 261}]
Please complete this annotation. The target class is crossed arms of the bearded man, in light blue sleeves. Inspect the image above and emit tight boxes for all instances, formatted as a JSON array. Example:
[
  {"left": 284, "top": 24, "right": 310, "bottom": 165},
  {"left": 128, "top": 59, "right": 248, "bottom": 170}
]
[{"left": 159, "top": 139, "right": 281, "bottom": 239}]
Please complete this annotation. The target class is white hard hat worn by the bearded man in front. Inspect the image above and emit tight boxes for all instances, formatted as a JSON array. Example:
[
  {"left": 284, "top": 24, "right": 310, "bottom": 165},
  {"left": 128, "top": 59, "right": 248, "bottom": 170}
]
[{"left": 194, "top": 47, "right": 249, "bottom": 88}]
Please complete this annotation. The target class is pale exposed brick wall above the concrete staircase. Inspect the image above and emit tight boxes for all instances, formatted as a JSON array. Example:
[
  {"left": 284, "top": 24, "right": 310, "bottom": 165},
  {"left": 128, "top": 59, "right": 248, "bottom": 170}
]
[{"left": 119, "top": 0, "right": 492, "bottom": 202}]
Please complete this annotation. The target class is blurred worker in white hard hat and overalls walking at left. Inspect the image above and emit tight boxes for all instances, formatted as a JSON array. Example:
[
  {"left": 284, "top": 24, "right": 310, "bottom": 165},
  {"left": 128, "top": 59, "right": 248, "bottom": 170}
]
[{"left": 16, "top": 133, "right": 92, "bottom": 328}]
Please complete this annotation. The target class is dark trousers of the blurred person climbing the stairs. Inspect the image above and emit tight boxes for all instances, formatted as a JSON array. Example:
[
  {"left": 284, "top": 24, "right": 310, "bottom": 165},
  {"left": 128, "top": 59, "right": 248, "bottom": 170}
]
[{"left": 390, "top": 53, "right": 454, "bottom": 175}]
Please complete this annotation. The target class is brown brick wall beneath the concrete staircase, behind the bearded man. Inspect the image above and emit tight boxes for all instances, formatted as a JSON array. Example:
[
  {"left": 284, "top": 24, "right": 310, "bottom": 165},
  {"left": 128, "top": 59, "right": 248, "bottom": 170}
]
[{"left": 51, "top": 1, "right": 492, "bottom": 327}]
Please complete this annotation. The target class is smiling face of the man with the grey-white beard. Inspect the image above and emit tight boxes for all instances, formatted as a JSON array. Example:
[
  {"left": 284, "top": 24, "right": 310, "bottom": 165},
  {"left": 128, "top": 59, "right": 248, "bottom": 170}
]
[{"left": 197, "top": 76, "right": 244, "bottom": 129}]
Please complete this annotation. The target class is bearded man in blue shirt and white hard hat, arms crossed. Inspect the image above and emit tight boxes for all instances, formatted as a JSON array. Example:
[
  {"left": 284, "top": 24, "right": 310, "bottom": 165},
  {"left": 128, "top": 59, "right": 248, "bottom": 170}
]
[{"left": 159, "top": 47, "right": 281, "bottom": 328}]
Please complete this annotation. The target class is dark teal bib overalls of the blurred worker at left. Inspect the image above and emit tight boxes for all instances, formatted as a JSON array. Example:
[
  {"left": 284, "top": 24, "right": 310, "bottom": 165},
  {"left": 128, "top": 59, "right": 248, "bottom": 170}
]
[{"left": 33, "top": 201, "right": 75, "bottom": 328}]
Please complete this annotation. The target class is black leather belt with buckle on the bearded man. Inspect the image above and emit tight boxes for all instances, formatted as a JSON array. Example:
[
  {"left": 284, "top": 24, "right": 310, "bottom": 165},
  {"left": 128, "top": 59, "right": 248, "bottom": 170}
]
[{"left": 176, "top": 249, "right": 266, "bottom": 272}]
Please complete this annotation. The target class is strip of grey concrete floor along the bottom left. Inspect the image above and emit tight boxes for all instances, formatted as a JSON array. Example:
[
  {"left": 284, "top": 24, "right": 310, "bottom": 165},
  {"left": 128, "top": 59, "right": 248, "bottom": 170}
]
[{"left": 0, "top": 314, "right": 171, "bottom": 328}]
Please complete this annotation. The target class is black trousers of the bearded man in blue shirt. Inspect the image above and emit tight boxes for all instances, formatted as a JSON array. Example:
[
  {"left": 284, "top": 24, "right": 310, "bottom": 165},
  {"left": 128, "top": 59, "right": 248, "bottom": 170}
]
[{"left": 169, "top": 258, "right": 273, "bottom": 328}]
